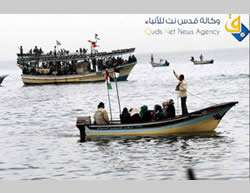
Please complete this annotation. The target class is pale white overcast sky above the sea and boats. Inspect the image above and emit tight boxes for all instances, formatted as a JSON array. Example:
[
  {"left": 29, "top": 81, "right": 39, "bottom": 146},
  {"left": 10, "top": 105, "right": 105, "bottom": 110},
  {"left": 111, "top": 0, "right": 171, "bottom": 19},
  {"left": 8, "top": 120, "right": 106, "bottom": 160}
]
[{"left": 0, "top": 14, "right": 249, "bottom": 60}]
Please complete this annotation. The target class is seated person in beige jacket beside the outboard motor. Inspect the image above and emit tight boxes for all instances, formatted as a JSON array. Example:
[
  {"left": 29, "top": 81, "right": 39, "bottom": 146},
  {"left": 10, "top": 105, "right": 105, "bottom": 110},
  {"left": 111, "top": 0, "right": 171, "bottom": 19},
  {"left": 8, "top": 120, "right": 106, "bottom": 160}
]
[{"left": 94, "top": 102, "right": 109, "bottom": 125}]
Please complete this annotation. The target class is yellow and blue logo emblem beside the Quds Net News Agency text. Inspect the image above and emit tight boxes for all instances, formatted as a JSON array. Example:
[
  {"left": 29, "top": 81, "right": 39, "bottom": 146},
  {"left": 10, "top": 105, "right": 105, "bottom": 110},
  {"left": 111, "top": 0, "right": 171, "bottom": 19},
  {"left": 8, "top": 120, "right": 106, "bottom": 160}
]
[{"left": 225, "top": 14, "right": 249, "bottom": 42}]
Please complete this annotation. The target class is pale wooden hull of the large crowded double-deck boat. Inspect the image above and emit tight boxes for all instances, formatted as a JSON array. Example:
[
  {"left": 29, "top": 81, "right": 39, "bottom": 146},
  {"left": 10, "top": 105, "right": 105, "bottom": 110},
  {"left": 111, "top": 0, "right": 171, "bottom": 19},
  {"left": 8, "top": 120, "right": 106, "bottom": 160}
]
[{"left": 22, "top": 62, "right": 136, "bottom": 85}]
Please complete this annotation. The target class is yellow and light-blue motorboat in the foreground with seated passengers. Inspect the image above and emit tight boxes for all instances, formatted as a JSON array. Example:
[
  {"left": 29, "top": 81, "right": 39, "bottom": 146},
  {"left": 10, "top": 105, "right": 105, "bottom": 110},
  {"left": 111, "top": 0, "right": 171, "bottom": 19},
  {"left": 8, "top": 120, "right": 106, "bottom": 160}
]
[{"left": 76, "top": 102, "right": 238, "bottom": 141}]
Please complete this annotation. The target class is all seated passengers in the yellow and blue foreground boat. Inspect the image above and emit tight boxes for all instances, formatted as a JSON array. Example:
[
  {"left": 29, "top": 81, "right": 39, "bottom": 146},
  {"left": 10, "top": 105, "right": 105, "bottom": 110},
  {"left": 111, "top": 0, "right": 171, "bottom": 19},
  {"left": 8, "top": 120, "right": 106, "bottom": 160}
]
[{"left": 94, "top": 99, "right": 176, "bottom": 125}]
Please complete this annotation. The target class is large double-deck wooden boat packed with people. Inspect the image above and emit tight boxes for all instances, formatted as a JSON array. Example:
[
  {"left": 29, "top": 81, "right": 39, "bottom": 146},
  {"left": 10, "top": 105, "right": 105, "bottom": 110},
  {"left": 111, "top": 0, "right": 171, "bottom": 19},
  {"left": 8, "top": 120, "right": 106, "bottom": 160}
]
[{"left": 17, "top": 48, "right": 137, "bottom": 85}]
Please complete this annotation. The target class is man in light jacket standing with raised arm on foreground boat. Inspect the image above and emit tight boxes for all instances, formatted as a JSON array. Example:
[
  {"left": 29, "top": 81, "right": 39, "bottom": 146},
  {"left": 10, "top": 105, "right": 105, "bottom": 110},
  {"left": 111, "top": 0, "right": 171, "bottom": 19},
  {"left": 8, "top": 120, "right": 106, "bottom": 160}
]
[{"left": 173, "top": 70, "right": 188, "bottom": 115}]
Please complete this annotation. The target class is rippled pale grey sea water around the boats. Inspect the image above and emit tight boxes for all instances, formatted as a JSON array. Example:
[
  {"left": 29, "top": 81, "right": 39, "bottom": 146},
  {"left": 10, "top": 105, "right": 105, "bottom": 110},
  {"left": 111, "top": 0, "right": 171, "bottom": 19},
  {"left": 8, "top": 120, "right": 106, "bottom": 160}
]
[{"left": 0, "top": 48, "right": 249, "bottom": 180}]
